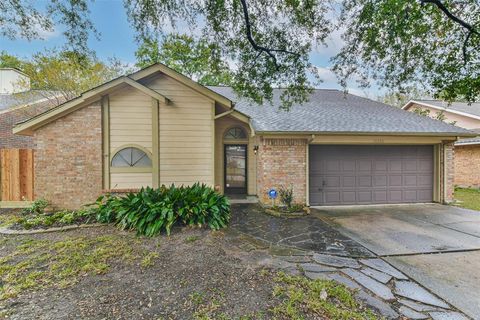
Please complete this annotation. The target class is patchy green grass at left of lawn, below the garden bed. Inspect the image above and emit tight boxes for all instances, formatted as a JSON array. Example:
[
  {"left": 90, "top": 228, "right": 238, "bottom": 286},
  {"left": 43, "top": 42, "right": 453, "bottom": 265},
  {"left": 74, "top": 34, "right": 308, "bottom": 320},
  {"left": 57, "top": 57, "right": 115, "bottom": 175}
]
[{"left": 0, "top": 235, "right": 158, "bottom": 300}]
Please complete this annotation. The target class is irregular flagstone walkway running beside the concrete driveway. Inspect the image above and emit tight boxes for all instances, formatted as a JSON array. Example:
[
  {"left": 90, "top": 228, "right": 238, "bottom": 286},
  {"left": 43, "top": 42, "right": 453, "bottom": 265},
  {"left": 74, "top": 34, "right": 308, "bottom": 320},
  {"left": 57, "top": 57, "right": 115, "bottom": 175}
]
[{"left": 231, "top": 204, "right": 468, "bottom": 320}]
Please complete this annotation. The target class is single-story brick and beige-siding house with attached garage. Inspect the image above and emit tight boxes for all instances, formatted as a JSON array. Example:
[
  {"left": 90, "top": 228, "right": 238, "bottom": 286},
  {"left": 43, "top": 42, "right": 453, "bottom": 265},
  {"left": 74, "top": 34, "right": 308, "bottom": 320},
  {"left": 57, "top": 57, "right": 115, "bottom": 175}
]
[{"left": 14, "top": 64, "right": 472, "bottom": 208}]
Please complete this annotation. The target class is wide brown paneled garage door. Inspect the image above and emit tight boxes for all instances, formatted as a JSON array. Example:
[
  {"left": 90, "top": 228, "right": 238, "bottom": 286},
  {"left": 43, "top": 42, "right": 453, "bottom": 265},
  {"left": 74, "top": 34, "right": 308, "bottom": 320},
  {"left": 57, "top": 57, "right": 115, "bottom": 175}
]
[{"left": 309, "top": 145, "right": 433, "bottom": 205}]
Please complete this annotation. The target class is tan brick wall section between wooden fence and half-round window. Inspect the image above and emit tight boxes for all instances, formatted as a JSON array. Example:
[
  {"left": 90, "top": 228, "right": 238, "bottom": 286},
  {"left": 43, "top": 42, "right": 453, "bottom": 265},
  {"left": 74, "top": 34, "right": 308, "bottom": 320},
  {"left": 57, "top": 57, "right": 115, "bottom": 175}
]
[{"left": 34, "top": 104, "right": 102, "bottom": 209}]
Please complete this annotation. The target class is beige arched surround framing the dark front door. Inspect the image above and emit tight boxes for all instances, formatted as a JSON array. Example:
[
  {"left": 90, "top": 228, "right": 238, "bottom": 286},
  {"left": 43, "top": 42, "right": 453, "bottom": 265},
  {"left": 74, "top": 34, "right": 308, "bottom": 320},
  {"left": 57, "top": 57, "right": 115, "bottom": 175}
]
[{"left": 215, "top": 116, "right": 257, "bottom": 195}]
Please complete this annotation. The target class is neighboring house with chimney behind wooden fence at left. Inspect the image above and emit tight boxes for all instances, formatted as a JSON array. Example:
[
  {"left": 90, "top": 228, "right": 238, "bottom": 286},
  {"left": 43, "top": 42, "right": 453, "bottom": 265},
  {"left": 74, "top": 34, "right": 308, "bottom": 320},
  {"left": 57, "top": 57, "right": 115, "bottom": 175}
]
[{"left": 0, "top": 68, "right": 65, "bottom": 149}]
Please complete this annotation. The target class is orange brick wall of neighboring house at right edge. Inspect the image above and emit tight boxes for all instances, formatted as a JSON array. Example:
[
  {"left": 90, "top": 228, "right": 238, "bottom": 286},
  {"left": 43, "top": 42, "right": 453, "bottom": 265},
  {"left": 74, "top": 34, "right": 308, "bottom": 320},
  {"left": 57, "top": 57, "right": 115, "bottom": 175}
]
[{"left": 455, "top": 145, "right": 480, "bottom": 188}]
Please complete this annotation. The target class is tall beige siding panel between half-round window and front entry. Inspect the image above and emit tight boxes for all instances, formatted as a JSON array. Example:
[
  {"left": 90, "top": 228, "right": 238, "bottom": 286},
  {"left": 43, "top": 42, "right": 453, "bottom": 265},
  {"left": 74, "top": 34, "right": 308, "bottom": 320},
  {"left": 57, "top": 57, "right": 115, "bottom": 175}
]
[{"left": 143, "top": 75, "right": 214, "bottom": 185}]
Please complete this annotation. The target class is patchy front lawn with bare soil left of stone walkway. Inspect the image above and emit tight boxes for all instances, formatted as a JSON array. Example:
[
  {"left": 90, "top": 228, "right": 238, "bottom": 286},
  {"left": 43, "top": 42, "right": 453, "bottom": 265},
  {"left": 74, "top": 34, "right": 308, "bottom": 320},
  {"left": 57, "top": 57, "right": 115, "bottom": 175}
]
[{"left": 0, "top": 210, "right": 379, "bottom": 320}]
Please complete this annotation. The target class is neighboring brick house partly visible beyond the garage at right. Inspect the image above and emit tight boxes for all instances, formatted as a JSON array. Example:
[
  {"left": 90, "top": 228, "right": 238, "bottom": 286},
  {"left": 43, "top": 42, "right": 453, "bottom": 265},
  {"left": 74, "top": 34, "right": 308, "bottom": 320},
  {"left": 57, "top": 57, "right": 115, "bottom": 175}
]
[{"left": 402, "top": 100, "right": 480, "bottom": 188}]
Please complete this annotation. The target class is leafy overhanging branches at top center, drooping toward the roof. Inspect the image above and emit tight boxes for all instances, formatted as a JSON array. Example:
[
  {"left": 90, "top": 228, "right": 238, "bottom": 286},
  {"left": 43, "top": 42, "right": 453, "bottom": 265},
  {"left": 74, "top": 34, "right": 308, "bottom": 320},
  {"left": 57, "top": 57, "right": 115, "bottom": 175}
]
[{"left": 125, "top": 0, "right": 331, "bottom": 108}]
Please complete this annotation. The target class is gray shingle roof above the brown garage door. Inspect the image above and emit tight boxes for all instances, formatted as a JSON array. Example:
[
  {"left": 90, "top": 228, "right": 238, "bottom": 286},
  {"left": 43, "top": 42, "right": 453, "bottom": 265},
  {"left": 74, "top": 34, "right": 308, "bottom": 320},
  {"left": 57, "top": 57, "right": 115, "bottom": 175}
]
[{"left": 209, "top": 87, "right": 469, "bottom": 134}]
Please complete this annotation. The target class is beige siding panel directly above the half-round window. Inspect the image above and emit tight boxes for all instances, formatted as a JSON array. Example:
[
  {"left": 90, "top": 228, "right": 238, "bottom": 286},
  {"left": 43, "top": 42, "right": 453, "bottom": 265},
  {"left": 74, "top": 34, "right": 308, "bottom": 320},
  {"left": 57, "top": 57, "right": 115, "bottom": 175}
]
[{"left": 110, "top": 86, "right": 152, "bottom": 154}]
